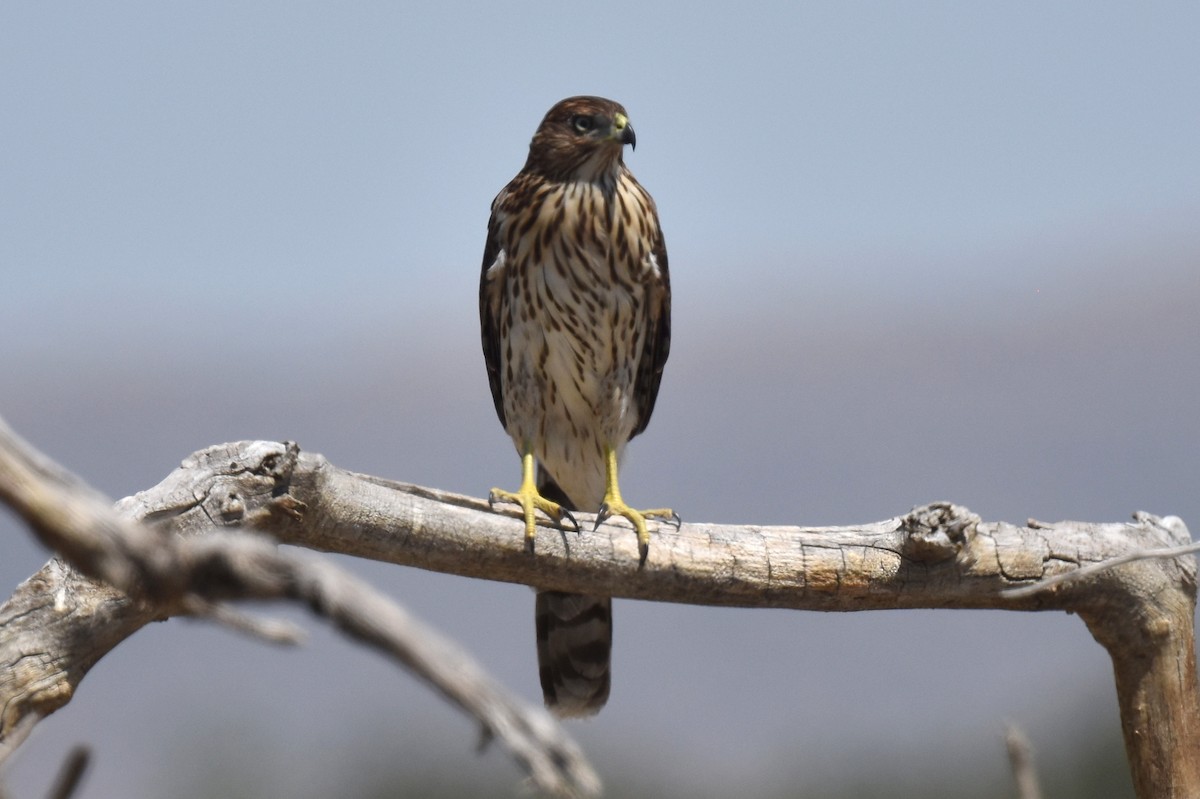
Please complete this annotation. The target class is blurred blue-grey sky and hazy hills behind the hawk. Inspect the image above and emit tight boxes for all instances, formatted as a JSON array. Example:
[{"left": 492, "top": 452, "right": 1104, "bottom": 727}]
[{"left": 0, "top": 0, "right": 1200, "bottom": 799}]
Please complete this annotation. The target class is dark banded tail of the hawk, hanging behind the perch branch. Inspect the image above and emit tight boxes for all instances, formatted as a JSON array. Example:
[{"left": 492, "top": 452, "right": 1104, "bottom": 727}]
[{"left": 534, "top": 469, "right": 612, "bottom": 716}]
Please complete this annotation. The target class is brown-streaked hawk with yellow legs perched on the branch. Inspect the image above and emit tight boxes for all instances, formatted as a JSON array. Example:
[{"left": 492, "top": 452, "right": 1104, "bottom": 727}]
[{"left": 479, "top": 97, "right": 678, "bottom": 716}]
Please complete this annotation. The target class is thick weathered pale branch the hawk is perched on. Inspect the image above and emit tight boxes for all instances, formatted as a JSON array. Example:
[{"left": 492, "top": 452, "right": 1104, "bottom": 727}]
[{"left": 0, "top": 441, "right": 1200, "bottom": 798}]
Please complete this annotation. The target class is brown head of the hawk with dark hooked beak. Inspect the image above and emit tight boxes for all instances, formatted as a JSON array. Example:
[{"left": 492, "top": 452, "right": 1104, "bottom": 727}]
[{"left": 524, "top": 97, "right": 637, "bottom": 181}]
